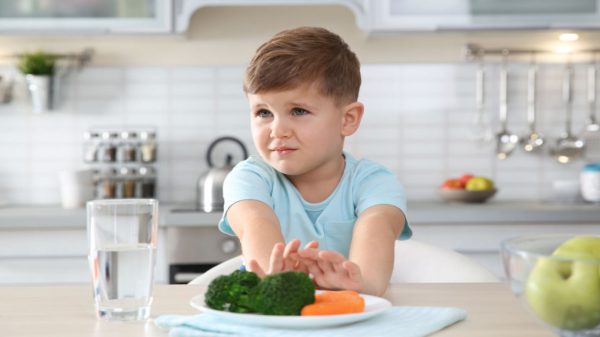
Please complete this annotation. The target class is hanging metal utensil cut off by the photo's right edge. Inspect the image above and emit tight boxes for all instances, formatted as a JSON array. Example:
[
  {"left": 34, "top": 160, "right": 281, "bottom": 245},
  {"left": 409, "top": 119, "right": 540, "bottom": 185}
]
[{"left": 581, "top": 55, "right": 600, "bottom": 162}]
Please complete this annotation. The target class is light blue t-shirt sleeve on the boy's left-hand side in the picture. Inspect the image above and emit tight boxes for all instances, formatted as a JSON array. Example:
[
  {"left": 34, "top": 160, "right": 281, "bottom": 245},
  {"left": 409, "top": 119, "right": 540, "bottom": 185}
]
[{"left": 218, "top": 159, "right": 273, "bottom": 236}]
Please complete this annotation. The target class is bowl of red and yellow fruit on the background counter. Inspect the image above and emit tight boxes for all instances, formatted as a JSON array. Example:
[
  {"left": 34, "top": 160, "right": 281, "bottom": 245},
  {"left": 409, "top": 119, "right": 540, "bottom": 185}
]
[{"left": 438, "top": 174, "right": 498, "bottom": 203}]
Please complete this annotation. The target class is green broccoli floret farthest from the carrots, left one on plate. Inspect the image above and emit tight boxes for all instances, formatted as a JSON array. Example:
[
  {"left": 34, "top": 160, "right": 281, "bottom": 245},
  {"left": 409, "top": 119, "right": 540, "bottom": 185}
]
[{"left": 204, "top": 270, "right": 260, "bottom": 313}]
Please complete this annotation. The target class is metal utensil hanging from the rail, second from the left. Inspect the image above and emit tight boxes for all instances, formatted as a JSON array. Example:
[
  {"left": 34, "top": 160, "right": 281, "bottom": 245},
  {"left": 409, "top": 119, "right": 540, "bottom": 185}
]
[{"left": 496, "top": 50, "right": 519, "bottom": 159}]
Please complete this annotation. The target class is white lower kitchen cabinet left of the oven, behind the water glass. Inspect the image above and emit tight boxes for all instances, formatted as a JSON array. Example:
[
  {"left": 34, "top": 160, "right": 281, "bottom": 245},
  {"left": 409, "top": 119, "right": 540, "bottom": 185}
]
[{"left": 0, "top": 227, "right": 168, "bottom": 285}]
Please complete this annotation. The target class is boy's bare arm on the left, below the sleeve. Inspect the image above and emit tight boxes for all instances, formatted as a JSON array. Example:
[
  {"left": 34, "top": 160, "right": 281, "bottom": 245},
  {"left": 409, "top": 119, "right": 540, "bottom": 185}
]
[{"left": 226, "top": 200, "right": 284, "bottom": 270}]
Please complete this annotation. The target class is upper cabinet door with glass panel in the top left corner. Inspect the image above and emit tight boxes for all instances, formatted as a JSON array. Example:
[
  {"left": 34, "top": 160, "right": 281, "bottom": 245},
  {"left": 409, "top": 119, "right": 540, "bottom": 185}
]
[{"left": 0, "top": 0, "right": 173, "bottom": 34}]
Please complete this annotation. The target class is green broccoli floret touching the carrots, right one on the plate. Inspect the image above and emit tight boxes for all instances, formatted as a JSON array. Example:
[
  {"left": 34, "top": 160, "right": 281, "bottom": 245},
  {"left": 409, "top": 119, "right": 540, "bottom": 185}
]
[{"left": 252, "top": 271, "right": 315, "bottom": 315}]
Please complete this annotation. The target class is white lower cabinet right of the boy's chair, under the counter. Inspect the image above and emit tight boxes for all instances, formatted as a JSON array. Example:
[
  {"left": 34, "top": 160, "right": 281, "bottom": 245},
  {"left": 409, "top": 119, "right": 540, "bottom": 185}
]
[{"left": 411, "top": 223, "right": 600, "bottom": 278}]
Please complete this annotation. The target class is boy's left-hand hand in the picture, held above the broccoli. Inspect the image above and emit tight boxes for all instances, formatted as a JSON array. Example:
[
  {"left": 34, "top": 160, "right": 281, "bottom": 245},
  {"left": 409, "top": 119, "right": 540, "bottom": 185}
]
[{"left": 248, "top": 240, "right": 319, "bottom": 277}]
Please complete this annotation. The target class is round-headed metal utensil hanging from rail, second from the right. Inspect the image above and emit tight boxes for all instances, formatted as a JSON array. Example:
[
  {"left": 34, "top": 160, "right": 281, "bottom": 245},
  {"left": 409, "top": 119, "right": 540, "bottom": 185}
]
[{"left": 550, "top": 62, "right": 585, "bottom": 164}]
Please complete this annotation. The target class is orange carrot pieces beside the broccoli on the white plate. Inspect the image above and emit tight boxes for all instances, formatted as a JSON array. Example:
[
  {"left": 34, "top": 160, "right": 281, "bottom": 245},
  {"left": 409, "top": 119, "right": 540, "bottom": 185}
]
[{"left": 300, "top": 290, "right": 365, "bottom": 316}]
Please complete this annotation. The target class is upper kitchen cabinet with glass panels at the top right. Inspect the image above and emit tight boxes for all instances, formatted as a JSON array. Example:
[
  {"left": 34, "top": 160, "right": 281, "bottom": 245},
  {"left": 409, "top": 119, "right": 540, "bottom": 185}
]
[{"left": 361, "top": 0, "right": 600, "bottom": 32}]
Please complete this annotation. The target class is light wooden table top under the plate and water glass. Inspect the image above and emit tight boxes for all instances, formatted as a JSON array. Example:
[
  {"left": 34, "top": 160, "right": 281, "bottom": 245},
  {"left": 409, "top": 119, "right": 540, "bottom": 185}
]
[{"left": 0, "top": 283, "right": 554, "bottom": 337}]
